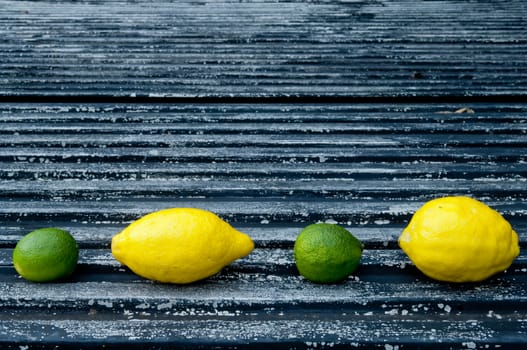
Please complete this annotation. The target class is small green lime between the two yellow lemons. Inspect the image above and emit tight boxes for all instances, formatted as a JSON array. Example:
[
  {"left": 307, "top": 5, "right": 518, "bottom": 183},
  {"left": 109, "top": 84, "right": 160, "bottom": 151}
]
[{"left": 293, "top": 223, "right": 363, "bottom": 283}]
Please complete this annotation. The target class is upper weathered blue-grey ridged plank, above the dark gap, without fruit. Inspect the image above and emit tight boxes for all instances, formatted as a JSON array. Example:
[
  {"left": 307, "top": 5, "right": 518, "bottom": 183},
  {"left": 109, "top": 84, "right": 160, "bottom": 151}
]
[{"left": 0, "top": 0, "right": 527, "bottom": 98}]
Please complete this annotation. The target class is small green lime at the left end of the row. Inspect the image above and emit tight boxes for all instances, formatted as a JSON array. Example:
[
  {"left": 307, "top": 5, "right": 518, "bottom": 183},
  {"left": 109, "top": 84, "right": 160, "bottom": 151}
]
[{"left": 13, "top": 227, "right": 79, "bottom": 282}]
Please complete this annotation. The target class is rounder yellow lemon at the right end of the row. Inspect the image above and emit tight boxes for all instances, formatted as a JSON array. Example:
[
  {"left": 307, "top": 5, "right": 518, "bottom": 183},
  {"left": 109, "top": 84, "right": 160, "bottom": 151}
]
[{"left": 399, "top": 196, "right": 520, "bottom": 282}]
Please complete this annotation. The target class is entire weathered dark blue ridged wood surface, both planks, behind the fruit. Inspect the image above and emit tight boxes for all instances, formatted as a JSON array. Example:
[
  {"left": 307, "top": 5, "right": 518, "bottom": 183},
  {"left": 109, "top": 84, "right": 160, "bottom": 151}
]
[{"left": 0, "top": 0, "right": 527, "bottom": 350}]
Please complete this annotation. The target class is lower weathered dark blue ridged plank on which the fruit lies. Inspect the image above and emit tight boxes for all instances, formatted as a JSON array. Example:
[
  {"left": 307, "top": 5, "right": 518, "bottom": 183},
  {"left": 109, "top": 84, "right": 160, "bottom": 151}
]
[{"left": 0, "top": 103, "right": 527, "bottom": 349}]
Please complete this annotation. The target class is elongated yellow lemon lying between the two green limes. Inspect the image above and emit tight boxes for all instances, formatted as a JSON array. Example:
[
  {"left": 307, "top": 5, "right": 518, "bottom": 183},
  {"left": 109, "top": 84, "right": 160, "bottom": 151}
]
[{"left": 112, "top": 208, "right": 254, "bottom": 284}]
